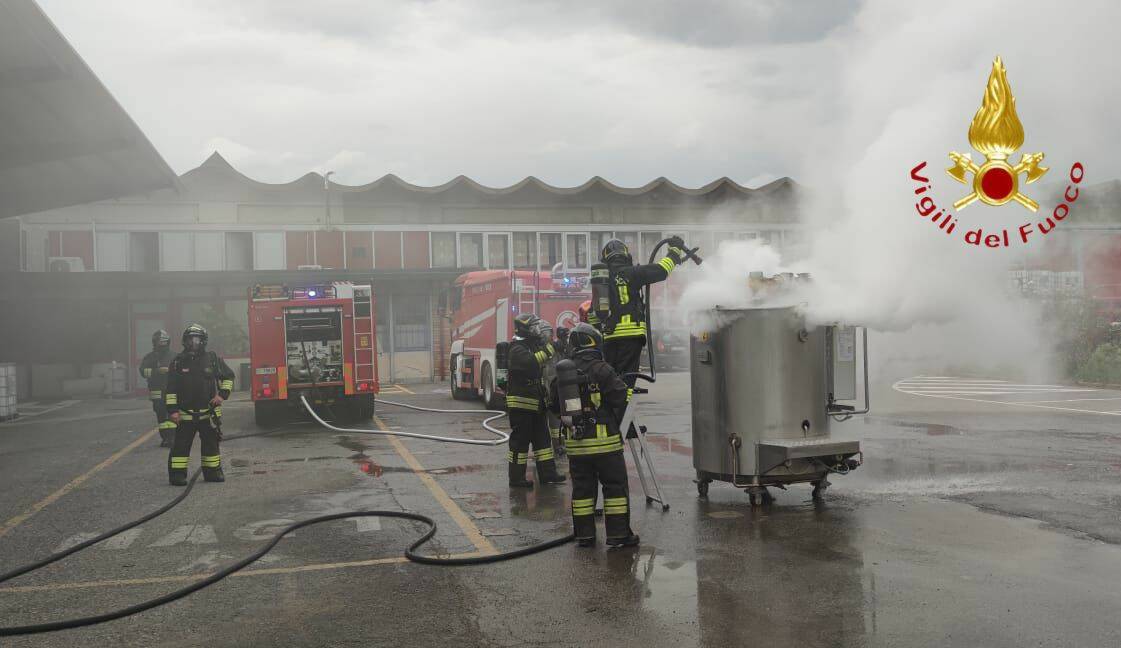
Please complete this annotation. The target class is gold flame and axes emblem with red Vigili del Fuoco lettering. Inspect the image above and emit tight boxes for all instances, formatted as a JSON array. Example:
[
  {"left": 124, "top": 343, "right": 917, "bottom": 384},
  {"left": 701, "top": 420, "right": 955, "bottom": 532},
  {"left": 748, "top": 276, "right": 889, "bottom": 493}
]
[{"left": 910, "top": 56, "right": 1084, "bottom": 248}]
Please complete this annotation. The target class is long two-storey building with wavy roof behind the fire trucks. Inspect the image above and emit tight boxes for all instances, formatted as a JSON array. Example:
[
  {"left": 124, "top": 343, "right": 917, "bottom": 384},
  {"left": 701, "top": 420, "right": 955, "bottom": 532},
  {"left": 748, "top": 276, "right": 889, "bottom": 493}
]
[{"left": 0, "top": 154, "right": 804, "bottom": 390}]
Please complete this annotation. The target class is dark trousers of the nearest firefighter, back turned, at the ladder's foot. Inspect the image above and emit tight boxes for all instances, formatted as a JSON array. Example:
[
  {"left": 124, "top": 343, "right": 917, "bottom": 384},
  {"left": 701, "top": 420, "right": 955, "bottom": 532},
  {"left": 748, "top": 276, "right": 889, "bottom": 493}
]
[{"left": 568, "top": 450, "right": 631, "bottom": 540}]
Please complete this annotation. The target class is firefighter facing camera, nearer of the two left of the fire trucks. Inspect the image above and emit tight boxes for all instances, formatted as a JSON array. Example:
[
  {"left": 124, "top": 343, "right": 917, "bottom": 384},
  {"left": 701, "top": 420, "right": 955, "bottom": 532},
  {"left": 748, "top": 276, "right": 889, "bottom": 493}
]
[{"left": 164, "top": 324, "right": 233, "bottom": 485}]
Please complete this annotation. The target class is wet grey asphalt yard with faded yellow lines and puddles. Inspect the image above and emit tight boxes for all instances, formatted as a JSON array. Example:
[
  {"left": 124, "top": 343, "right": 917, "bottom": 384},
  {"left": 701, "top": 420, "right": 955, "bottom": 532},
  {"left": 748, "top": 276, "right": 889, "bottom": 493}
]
[{"left": 0, "top": 373, "right": 1121, "bottom": 648}]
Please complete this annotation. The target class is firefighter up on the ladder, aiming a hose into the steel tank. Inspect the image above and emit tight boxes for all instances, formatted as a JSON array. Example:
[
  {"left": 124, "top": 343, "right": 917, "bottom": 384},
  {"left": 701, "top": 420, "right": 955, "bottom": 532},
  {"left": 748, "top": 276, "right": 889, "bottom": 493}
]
[{"left": 600, "top": 237, "right": 686, "bottom": 387}]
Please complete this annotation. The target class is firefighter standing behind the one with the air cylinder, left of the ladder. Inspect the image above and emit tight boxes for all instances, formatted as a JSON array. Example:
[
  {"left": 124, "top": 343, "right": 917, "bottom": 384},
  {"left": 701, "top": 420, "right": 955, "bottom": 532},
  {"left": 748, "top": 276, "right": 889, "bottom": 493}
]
[{"left": 506, "top": 313, "right": 565, "bottom": 487}]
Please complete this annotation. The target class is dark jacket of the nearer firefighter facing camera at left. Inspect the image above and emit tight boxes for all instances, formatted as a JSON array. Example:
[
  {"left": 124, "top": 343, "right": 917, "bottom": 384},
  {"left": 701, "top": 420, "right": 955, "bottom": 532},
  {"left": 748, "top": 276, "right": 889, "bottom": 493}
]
[{"left": 164, "top": 351, "right": 233, "bottom": 420}]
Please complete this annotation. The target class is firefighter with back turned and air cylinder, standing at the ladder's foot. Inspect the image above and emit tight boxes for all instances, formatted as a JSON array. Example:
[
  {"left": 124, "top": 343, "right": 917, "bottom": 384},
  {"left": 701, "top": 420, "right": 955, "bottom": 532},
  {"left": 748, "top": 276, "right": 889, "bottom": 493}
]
[{"left": 566, "top": 323, "right": 639, "bottom": 547}]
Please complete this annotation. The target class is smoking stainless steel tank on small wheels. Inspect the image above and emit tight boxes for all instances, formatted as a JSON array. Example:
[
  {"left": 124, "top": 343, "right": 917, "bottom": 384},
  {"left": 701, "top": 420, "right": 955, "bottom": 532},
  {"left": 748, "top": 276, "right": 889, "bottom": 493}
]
[{"left": 689, "top": 306, "right": 868, "bottom": 502}]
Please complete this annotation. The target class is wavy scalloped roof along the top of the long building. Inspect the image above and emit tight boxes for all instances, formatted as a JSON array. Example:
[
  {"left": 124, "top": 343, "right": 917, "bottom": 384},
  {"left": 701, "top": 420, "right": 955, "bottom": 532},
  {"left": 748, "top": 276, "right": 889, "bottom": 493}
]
[{"left": 168, "top": 152, "right": 797, "bottom": 204}]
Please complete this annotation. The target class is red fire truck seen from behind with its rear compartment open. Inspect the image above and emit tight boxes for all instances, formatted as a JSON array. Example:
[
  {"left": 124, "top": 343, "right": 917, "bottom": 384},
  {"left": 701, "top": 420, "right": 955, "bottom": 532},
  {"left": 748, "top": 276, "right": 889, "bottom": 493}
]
[{"left": 249, "top": 281, "right": 379, "bottom": 426}]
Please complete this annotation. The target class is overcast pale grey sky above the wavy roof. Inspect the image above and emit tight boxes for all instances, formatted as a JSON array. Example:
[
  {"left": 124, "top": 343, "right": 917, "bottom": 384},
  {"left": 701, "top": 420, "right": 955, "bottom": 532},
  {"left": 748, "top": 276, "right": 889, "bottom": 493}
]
[{"left": 39, "top": 0, "right": 1121, "bottom": 186}]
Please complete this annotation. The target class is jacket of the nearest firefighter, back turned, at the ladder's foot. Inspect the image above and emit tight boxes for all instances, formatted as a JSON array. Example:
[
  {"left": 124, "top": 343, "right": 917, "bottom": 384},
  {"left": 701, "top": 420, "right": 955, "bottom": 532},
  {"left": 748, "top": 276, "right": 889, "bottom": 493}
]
[{"left": 565, "top": 352, "right": 630, "bottom": 456}]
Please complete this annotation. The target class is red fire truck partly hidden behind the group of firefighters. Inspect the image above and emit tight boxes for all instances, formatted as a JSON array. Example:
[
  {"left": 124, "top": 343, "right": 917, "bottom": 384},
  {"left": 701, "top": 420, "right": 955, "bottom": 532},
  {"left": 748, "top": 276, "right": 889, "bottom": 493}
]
[{"left": 448, "top": 264, "right": 592, "bottom": 408}]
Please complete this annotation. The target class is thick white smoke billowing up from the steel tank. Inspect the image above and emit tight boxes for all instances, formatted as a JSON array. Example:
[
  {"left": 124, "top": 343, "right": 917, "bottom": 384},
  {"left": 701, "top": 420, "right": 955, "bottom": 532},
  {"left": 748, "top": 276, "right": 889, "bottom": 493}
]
[{"left": 684, "top": 0, "right": 1121, "bottom": 378}]
